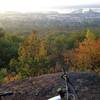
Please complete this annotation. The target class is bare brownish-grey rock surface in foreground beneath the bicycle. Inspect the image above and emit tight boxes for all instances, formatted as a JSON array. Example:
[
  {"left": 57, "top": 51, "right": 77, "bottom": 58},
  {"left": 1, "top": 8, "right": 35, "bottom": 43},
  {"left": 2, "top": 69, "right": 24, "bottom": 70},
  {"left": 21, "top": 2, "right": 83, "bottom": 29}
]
[{"left": 0, "top": 72, "right": 100, "bottom": 100}]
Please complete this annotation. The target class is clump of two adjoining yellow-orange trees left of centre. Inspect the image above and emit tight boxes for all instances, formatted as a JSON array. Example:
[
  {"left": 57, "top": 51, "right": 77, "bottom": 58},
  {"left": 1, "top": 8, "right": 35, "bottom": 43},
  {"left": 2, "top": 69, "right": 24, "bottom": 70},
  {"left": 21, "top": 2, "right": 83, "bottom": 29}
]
[{"left": 18, "top": 32, "right": 48, "bottom": 76}]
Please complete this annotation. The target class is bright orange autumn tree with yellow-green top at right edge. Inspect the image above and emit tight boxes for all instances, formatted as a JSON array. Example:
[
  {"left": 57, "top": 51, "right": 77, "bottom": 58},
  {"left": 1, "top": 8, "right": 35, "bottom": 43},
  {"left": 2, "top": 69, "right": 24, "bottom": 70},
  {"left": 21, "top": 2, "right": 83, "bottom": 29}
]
[{"left": 75, "top": 31, "right": 100, "bottom": 71}]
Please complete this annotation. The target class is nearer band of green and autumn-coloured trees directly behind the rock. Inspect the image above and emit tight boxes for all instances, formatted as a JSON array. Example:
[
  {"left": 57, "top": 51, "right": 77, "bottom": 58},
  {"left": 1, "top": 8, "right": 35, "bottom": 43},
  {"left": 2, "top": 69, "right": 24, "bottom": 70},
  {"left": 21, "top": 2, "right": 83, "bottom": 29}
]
[{"left": 0, "top": 29, "right": 100, "bottom": 82}]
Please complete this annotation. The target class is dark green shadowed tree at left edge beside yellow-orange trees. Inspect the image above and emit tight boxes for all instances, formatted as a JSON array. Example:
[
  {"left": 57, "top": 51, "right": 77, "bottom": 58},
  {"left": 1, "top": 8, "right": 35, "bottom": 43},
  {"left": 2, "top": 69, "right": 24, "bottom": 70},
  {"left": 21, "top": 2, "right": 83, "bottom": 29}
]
[{"left": 0, "top": 34, "right": 21, "bottom": 68}]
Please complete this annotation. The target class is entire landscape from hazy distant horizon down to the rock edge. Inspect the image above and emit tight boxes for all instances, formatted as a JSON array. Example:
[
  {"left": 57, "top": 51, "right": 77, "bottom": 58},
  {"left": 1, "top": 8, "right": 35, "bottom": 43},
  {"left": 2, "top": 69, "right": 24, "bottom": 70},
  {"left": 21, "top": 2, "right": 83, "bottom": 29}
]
[{"left": 0, "top": 9, "right": 100, "bottom": 83}]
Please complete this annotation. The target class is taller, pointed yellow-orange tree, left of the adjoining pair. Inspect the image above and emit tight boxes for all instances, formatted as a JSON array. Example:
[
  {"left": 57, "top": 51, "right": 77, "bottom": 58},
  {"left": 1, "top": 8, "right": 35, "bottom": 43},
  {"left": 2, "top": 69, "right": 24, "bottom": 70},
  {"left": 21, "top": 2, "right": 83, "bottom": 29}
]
[{"left": 18, "top": 32, "right": 39, "bottom": 77}]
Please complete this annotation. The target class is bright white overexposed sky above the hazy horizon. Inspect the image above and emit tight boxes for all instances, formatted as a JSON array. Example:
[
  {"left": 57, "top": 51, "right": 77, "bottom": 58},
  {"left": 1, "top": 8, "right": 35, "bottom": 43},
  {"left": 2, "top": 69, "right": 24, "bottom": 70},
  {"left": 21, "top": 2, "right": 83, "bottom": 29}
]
[{"left": 0, "top": 0, "right": 100, "bottom": 12}]
